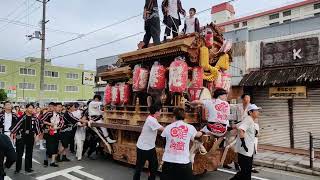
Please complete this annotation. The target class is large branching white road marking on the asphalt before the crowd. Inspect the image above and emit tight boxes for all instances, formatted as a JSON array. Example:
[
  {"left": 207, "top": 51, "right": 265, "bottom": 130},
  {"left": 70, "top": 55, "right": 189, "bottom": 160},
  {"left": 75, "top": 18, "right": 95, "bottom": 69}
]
[{"left": 36, "top": 166, "right": 103, "bottom": 180}]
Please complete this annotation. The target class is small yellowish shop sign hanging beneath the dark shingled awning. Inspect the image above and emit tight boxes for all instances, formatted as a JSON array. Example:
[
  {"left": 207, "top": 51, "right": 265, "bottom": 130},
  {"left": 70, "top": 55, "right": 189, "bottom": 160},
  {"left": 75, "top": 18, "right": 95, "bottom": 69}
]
[{"left": 269, "top": 86, "right": 307, "bottom": 99}]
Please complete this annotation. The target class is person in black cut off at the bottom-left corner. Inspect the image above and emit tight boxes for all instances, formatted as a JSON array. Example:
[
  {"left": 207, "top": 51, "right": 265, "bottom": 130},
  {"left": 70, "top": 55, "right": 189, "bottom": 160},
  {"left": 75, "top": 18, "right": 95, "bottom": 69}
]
[{"left": 0, "top": 134, "right": 17, "bottom": 180}]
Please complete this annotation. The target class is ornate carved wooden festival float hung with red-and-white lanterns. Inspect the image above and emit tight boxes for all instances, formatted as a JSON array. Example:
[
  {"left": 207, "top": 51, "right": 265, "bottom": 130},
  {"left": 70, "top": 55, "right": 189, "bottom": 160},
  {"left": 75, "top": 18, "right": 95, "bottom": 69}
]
[{"left": 93, "top": 24, "right": 234, "bottom": 174}]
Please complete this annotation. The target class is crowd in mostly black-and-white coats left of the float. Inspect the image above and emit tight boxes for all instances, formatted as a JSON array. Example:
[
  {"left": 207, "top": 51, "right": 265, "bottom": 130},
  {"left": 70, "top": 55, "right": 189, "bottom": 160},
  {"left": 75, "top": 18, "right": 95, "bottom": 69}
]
[{"left": 0, "top": 95, "right": 115, "bottom": 177}]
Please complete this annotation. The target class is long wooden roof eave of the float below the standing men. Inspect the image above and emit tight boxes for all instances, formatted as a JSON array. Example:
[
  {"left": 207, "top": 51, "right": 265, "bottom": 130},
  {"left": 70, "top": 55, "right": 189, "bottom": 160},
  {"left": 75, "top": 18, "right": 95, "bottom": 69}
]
[{"left": 119, "top": 35, "right": 195, "bottom": 64}]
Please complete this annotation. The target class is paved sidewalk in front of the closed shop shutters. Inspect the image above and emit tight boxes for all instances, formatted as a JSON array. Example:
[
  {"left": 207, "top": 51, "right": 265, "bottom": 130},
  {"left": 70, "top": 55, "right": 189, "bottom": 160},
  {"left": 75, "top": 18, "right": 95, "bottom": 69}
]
[{"left": 254, "top": 150, "right": 320, "bottom": 176}]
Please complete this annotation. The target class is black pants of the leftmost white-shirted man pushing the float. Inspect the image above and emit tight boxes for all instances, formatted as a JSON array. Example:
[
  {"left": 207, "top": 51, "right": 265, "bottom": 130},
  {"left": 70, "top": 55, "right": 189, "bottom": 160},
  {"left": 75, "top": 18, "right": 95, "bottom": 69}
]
[{"left": 133, "top": 148, "right": 158, "bottom": 180}]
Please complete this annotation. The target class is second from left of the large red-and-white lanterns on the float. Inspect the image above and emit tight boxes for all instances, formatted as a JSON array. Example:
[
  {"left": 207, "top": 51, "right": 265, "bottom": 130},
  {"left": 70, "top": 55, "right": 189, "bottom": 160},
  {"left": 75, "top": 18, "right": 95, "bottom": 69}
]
[{"left": 149, "top": 62, "right": 166, "bottom": 90}]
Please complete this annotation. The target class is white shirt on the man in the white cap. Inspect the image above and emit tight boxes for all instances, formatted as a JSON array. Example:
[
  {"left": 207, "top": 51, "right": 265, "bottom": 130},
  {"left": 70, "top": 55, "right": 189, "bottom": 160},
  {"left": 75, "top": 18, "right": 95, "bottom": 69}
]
[{"left": 236, "top": 116, "right": 256, "bottom": 157}]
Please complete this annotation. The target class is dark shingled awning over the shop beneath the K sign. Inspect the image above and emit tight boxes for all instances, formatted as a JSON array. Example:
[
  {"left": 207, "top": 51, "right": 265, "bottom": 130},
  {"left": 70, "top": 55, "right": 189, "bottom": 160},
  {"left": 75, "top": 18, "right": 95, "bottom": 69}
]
[{"left": 240, "top": 65, "right": 320, "bottom": 86}]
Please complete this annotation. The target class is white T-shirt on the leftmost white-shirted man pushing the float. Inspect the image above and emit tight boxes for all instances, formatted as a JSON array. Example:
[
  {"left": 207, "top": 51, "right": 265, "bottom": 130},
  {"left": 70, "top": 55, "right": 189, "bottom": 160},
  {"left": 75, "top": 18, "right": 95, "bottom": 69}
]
[{"left": 137, "top": 115, "right": 162, "bottom": 151}]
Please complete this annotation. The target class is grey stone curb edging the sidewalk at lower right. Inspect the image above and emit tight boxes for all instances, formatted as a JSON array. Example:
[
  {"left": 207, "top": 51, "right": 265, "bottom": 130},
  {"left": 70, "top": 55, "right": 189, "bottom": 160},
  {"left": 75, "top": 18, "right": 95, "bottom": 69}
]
[{"left": 253, "top": 159, "right": 320, "bottom": 176}]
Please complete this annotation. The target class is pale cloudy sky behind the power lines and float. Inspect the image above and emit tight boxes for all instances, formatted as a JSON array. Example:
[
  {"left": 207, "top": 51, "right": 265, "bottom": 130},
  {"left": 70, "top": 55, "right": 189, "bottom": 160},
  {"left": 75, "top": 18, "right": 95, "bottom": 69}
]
[{"left": 0, "top": 0, "right": 302, "bottom": 70}]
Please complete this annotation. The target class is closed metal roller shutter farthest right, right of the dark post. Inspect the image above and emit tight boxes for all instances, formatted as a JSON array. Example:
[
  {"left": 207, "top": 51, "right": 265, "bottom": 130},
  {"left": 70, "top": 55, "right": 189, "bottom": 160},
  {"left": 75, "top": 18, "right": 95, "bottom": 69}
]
[{"left": 293, "top": 88, "right": 320, "bottom": 150}]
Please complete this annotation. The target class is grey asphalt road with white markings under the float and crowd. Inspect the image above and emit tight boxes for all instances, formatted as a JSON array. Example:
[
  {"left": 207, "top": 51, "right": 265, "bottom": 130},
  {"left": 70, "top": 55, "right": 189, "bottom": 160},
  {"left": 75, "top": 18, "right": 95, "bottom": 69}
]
[{"left": 3, "top": 150, "right": 320, "bottom": 180}]
